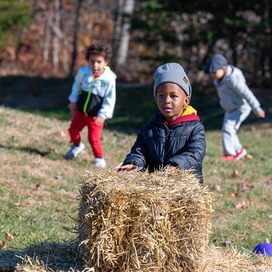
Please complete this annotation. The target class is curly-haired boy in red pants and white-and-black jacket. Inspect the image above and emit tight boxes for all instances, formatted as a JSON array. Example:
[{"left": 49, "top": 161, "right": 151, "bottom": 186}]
[{"left": 65, "top": 42, "right": 116, "bottom": 168}]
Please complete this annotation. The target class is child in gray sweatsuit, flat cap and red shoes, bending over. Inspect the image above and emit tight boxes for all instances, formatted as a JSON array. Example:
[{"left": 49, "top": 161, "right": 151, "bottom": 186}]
[{"left": 204, "top": 54, "right": 265, "bottom": 161}]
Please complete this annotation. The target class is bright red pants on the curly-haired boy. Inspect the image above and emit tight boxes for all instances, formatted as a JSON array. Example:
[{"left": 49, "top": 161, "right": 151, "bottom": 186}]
[{"left": 69, "top": 111, "right": 104, "bottom": 158}]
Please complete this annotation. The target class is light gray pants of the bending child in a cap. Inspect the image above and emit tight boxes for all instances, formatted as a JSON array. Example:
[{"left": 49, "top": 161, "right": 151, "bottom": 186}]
[{"left": 222, "top": 105, "right": 251, "bottom": 156}]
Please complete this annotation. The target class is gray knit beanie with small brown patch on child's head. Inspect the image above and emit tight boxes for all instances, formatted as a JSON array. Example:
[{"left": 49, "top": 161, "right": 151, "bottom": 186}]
[{"left": 153, "top": 63, "right": 192, "bottom": 98}]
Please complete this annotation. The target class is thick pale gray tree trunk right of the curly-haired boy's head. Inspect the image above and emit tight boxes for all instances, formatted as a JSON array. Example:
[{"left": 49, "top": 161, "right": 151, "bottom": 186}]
[{"left": 112, "top": 0, "right": 135, "bottom": 72}]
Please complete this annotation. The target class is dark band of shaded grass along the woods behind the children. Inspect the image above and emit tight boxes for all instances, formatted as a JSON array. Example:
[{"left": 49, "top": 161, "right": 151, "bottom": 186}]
[{"left": 0, "top": 76, "right": 272, "bottom": 133}]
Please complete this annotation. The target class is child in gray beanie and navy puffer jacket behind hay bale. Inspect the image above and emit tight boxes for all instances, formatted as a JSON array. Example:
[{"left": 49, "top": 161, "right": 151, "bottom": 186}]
[{"left": 116, "top": 63, "right": 206, "bottom": 183}]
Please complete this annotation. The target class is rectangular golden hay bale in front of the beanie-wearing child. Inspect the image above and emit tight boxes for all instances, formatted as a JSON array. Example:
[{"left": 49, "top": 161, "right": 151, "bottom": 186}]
[{"left": 78, "top": 170, "right": 214, "bottom": 272}]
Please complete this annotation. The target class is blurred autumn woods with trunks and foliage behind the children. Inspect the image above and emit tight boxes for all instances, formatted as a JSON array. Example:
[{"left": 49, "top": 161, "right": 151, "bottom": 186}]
[{"left": 0, "top": 0, "right": 272, "bottom": 84}]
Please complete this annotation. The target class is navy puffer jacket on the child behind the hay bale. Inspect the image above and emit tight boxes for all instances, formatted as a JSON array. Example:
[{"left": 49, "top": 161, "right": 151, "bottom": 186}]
[{"left": 123, "top": 111, "right": 206, "bottom": 183}]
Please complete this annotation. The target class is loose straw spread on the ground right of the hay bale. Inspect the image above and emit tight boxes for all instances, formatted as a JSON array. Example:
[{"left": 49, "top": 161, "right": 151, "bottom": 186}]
[{"left": 202, "top": 246, "right": 272, "bottom": 272}]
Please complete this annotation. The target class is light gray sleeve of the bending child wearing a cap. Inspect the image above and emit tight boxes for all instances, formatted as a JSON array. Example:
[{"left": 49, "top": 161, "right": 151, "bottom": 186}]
[{"left": 229, "top": 71, "right": 262, "bottom": 114}]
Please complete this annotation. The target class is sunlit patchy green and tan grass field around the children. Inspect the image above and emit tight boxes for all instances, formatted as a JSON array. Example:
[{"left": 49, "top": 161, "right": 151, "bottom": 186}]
[{"left": 0, "top": 79, "right": 272, "bottom": 271}]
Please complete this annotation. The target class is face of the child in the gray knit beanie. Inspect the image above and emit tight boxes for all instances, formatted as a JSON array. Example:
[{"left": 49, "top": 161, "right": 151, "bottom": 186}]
[{"left": 157, "top": 82, "right": 191, "bottom": 123}]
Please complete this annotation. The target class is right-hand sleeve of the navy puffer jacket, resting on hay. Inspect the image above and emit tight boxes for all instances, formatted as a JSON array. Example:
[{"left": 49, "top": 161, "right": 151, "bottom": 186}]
[{"left": 165, "top": 122, "right": 206, "bottom": 176}]
